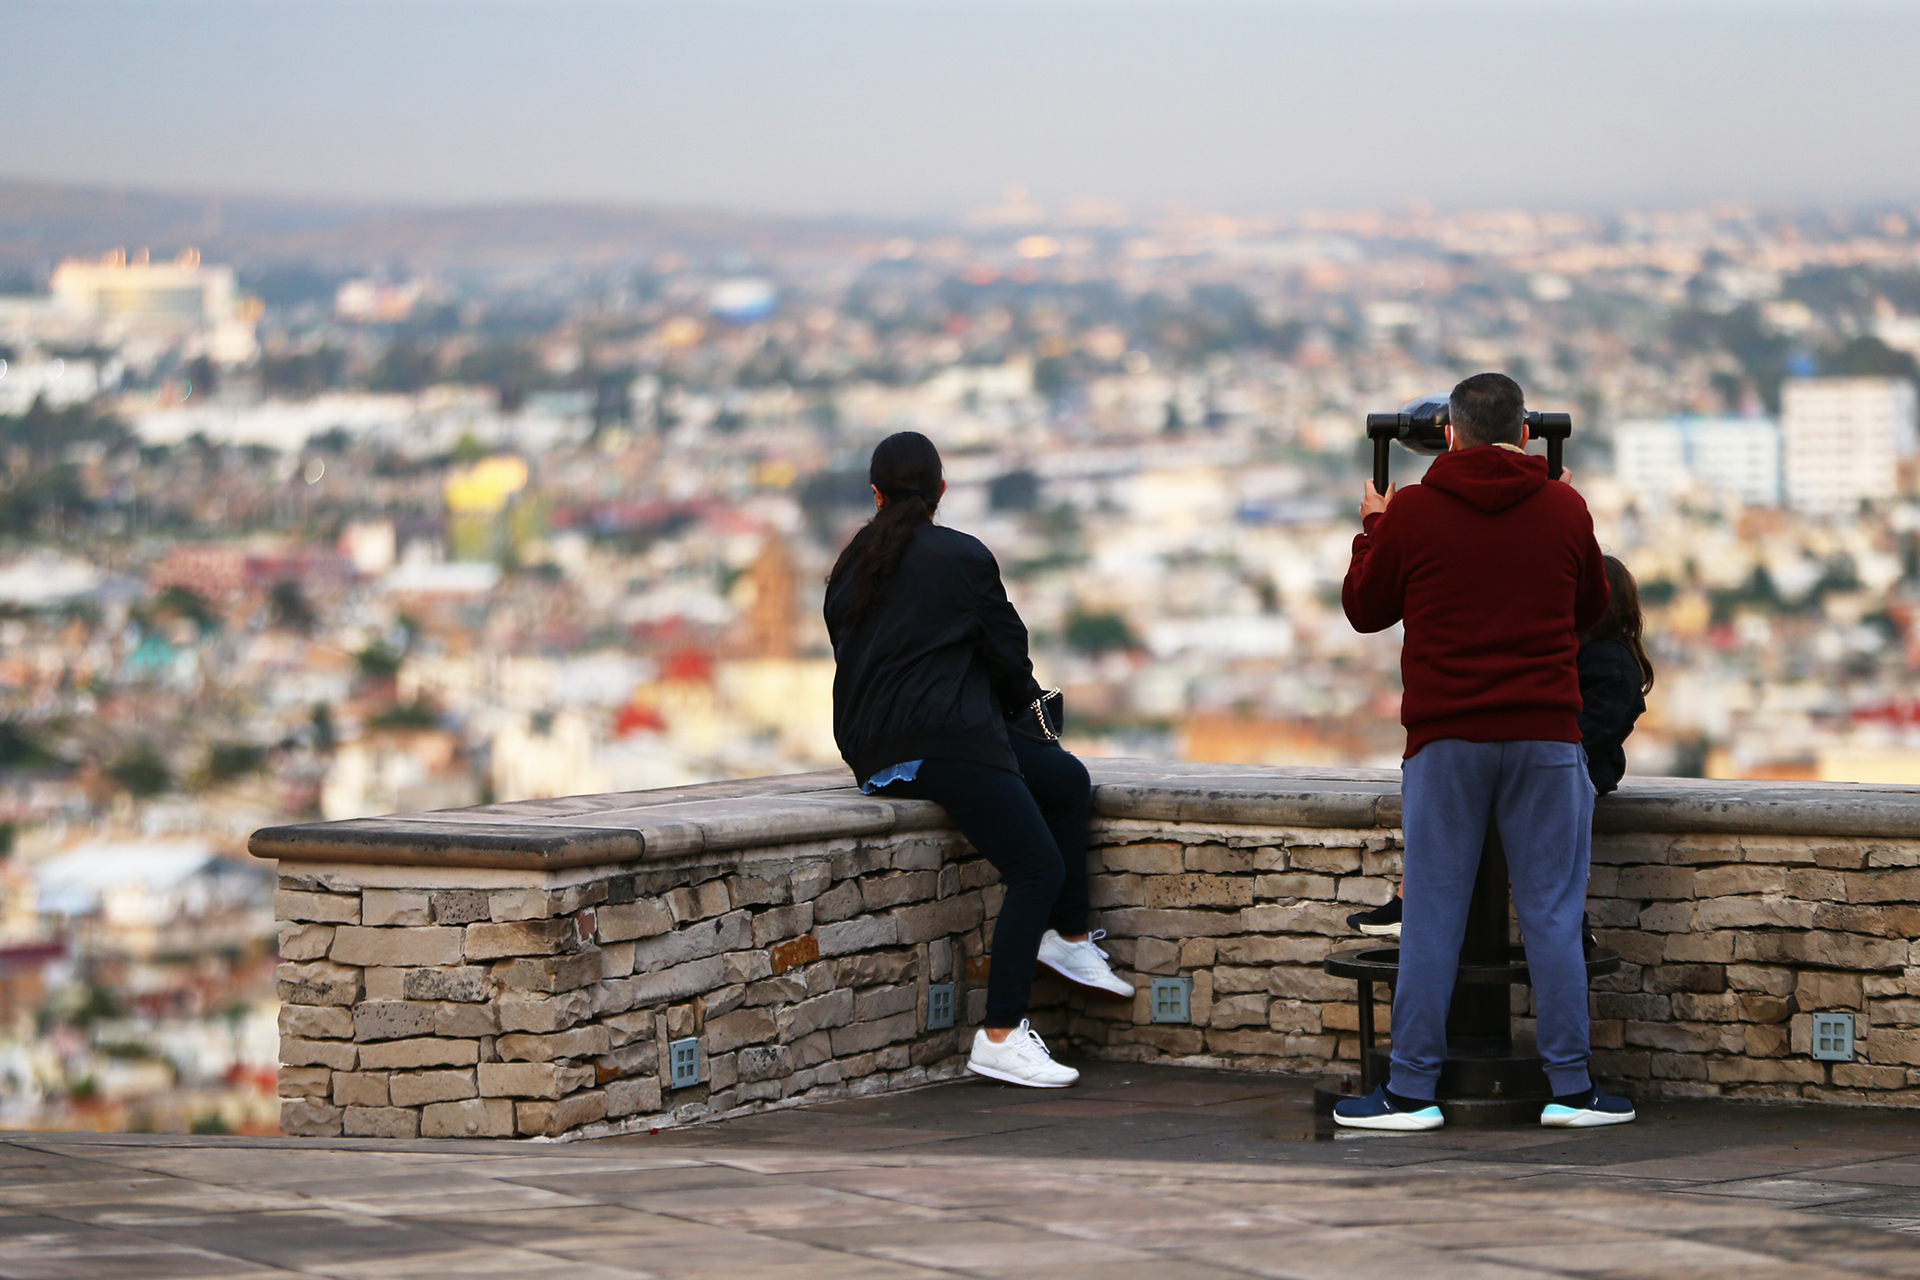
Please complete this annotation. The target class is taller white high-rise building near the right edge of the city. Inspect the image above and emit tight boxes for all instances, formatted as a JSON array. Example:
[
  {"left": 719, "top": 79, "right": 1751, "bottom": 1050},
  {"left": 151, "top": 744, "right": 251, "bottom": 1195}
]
[{"left": 1780, "top": 378, "right": 1914, "bottom": 514}]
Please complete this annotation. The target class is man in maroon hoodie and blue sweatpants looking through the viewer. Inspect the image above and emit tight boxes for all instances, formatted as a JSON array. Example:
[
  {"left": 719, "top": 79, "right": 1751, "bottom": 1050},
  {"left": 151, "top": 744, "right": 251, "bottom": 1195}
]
[{"left": 1334, "top": 374, "right": 1634, "bottom": 1128}]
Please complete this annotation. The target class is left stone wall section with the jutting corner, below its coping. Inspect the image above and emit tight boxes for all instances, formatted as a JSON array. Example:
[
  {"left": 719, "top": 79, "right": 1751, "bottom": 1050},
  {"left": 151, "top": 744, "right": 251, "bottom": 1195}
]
[{"left": 276, "top": 833, "right": 1000, "bottom": 1138}]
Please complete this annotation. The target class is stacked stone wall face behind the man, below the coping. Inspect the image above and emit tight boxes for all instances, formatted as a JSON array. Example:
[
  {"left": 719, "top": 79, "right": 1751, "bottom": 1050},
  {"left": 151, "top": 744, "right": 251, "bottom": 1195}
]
[{"left": 1035, "top": 819, "right": 1920, "bottom": 1105}]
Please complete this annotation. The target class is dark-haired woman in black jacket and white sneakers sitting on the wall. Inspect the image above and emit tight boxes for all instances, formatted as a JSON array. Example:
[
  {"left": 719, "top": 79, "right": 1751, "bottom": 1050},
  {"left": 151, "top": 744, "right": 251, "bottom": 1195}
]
[{"left": 826, "top": 432, "right": 1133, "bottom": 1088}]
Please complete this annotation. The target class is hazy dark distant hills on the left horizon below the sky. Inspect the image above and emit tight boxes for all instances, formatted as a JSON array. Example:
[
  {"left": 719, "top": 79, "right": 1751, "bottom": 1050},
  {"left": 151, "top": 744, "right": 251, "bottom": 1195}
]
[{"left": 0, "top": 178, "right": 925, "bottom": 276}]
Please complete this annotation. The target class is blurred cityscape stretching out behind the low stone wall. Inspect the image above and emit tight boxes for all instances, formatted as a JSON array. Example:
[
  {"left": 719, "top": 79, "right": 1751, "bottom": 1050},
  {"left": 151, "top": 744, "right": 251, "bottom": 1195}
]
[{"left": 0, "top": 184, "right": 1920, "bottom": 1132}]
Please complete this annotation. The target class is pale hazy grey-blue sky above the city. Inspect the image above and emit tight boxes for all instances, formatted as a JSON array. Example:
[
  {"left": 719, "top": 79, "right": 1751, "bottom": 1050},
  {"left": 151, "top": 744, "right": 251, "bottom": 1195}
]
[{"left": 11, "top": 0, "right": 1920, "bottom": 215}]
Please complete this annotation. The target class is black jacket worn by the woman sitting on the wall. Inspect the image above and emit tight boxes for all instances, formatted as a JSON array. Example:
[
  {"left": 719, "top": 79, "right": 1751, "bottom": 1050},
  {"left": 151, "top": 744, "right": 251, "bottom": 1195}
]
[{"left": 826, "top": 524, "right": 1041, "bottom": 781}]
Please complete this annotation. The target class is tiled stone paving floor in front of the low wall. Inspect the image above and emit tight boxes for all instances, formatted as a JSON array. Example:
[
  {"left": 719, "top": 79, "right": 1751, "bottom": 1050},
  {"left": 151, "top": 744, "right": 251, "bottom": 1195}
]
[{"left": 11, "top": 1063, "right": 1920, "bottom": 1280}]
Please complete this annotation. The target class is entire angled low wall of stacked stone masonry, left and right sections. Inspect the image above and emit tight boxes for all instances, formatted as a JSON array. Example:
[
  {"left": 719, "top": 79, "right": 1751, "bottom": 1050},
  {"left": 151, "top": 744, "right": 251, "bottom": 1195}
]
[{"left": 255, "top": 762, "right": 1920, "bottom": 1138}]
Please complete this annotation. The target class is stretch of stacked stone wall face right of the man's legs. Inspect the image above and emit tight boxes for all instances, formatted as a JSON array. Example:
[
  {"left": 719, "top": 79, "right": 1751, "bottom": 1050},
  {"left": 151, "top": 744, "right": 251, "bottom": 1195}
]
[{"left": 1590, "top": 835, "right": 1920, "bottom": 1105}]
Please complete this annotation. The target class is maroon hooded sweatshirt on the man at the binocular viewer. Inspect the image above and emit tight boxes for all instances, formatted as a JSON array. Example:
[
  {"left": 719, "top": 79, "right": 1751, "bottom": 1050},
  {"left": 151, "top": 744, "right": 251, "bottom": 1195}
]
[{"left": 1340, "top": 445, "right": 1607, "bottom": 756}]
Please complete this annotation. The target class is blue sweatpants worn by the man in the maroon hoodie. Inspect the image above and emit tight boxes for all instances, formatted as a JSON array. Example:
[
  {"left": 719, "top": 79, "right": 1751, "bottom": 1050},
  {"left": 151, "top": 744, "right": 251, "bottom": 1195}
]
[{"left": 1392, "top": 739, "right": 1594, "bottom": 1100}]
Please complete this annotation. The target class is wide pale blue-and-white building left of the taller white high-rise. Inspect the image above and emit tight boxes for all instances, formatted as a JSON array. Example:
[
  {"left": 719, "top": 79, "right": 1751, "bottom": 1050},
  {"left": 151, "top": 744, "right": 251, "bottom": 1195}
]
[{"left": 1613, "top": 418, "right": 1780, "bottom": 507}]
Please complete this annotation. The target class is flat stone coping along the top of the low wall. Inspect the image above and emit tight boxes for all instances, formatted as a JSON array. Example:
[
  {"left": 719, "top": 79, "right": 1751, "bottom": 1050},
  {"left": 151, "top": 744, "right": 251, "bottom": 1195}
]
[{"left": 250, "top": 758, "right": 1920, "bottom": 869}]
